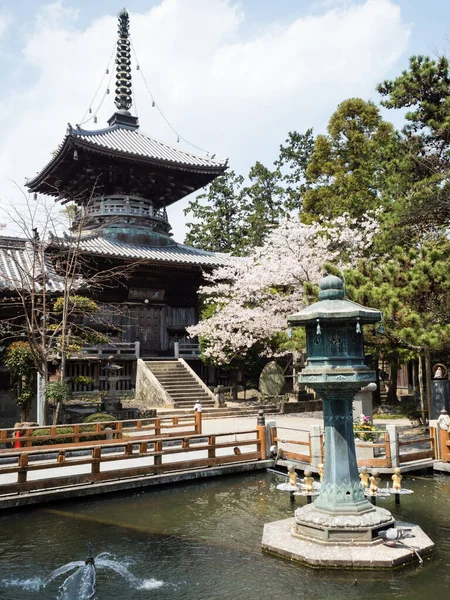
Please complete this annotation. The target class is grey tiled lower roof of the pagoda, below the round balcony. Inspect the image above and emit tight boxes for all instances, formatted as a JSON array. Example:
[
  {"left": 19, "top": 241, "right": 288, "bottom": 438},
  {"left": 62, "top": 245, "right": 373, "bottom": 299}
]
[{"left": 74, "top": 236, "right": 232, "bottom": 267}]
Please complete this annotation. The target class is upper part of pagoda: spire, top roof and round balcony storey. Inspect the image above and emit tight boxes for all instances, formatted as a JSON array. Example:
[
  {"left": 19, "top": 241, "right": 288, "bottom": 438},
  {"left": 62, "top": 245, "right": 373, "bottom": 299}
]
[{"left": 26, "top": 9, "right": 226, "bottom": 253}]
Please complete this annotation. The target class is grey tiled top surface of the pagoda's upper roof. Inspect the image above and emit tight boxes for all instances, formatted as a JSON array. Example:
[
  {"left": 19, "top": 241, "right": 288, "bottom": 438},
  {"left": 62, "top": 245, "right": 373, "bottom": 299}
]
[{"left": 70, "top": 125, "right": 226, "bottom": 171}]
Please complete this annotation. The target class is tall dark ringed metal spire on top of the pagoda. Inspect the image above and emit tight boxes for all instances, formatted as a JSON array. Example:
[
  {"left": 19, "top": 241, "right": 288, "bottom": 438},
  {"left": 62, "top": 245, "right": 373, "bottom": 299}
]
[{"left": 115, "top": 8, "right": 133, "bottom": 111}]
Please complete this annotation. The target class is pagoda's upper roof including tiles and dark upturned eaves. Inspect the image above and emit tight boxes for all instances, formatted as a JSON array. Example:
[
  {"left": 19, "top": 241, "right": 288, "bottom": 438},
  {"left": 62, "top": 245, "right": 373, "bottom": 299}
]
[{"left": 26, "top": 123, "right": 227, "bottom": 199}]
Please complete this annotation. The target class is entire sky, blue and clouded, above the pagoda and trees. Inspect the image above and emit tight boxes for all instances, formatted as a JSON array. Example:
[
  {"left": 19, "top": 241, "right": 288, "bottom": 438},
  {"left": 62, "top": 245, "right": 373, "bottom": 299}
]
[{"left": 0, "top": 0, "right": 450, "bottom": 241}]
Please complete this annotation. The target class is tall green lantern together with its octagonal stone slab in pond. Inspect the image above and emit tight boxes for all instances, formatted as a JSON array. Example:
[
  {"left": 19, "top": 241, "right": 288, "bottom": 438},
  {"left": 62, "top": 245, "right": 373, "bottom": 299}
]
[{"left": 262, "top": 275, "right": 433, "bottom": 568}]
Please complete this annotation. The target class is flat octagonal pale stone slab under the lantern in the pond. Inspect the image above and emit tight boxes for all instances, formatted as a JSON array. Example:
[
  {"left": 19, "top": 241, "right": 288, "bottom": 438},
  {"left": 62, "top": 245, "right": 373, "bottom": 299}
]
[{"left": 262, "top": 518, "right": 434, "bottom": 569}]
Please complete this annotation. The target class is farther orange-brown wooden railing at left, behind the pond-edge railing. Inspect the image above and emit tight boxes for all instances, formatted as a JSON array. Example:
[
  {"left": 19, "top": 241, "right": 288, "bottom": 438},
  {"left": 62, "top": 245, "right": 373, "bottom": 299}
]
[{"left": 0, "top": 413, "right": 202, "bottom": 454}]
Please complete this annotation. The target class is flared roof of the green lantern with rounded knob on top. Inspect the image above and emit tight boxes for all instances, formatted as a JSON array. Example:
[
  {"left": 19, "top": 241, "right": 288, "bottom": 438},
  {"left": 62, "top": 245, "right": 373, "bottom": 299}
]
[{"left": 288, "top": 275, "right": 383, "bottom": 327}]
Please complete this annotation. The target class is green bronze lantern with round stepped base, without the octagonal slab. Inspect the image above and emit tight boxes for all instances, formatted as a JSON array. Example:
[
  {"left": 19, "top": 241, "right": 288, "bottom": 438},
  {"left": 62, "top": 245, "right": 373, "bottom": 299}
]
[{"left": 288, "top": 275, "right": 394, "bottom": 542}]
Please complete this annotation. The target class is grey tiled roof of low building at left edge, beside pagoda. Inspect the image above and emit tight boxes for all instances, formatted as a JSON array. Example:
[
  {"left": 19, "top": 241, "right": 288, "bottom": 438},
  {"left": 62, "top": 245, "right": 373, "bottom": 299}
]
[{"left": 0, "top": 237, "right": 64, "bottom": 292}]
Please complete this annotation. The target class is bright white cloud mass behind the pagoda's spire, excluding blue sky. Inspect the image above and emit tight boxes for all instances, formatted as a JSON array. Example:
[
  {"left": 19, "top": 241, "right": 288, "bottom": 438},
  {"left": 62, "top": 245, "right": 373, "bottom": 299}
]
[{"left": 0, "top": 0, "right": 410, "bottom": 241}]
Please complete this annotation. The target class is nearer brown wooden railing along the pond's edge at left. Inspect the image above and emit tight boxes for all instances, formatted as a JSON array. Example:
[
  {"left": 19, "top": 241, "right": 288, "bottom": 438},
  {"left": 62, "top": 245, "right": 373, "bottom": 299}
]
[{"left": 0, "top": 426, "right": 266, "bottom": 495}]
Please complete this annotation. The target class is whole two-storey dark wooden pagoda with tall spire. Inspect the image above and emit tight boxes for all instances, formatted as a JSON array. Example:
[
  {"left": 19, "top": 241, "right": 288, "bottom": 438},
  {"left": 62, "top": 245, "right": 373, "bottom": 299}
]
[{"left": 20, "top": 9, "right": 230, "bottom": 356}]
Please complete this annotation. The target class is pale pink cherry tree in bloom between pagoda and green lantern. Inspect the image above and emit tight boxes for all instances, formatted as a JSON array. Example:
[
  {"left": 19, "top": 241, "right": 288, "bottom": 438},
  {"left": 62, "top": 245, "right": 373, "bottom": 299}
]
[{"left": 188, "top": 214, "right": 378, "bottom": 366}]
